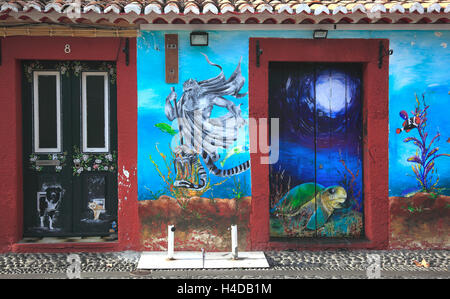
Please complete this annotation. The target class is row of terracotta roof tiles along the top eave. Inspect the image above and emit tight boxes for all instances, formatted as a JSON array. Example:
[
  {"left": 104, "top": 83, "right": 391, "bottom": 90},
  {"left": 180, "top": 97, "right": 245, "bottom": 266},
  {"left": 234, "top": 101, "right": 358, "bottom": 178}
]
[{"left": 0, "top": 0, "right": 450, "bottom": 24}]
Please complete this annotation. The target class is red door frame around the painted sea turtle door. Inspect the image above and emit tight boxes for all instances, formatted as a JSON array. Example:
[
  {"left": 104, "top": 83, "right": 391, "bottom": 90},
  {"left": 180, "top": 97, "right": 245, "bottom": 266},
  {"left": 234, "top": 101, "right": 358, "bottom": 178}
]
[{"left": 249, "top": 38, "right": 389, "bottom": 250}]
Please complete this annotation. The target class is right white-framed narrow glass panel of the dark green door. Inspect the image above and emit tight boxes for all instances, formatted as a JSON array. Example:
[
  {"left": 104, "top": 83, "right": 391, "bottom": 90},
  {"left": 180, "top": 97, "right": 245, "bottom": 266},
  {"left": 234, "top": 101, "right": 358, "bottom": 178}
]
[{"left": 82, "top": 72, "right": 109, "bottom": 152}]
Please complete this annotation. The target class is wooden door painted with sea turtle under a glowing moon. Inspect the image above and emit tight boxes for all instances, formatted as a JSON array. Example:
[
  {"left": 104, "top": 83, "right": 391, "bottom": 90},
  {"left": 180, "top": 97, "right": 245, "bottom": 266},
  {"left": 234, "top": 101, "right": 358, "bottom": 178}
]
[{"left": 269, "top": 62, "right": 364, "bottom": 239}]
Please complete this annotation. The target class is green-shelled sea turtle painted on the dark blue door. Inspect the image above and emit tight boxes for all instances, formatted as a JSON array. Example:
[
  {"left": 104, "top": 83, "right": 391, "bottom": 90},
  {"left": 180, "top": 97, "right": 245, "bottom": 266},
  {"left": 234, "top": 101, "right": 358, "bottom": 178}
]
[{"left": 270, "top": 183, "right": 347, "bottom": 230}]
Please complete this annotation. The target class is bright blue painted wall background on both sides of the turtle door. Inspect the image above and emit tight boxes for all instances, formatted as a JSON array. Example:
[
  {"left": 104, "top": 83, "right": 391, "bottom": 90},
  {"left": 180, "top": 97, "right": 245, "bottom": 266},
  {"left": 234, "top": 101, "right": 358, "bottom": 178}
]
[{"left": 137, "top": 30, "right": 450, "bottom": 203}]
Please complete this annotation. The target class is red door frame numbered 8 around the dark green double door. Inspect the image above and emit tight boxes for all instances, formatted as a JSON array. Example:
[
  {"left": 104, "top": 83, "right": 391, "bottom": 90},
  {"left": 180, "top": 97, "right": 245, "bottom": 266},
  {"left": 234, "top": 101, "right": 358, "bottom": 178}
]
[{"left": 0, "top": 37, "right": 140, "bottom": 252}]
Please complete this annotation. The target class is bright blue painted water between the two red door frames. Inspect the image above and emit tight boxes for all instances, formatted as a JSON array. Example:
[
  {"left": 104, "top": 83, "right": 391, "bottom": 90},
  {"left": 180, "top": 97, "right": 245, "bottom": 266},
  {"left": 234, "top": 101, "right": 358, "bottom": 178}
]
[{"left": 138, "top": 33, "right": 251, "bottom": 200}]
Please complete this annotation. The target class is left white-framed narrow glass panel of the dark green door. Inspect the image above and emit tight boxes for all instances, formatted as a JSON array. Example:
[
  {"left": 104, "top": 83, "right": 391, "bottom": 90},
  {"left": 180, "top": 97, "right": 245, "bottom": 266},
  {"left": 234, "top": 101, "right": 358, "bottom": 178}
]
[{"left": 33, "top": 72, "right": 61, "bottom": 153}]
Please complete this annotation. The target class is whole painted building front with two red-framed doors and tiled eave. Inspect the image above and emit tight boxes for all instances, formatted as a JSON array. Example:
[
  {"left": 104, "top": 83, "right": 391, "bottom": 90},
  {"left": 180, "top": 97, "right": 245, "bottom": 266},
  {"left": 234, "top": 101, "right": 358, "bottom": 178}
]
[{"left": 0, "top": 1, "right": 450, "bottom": 252}]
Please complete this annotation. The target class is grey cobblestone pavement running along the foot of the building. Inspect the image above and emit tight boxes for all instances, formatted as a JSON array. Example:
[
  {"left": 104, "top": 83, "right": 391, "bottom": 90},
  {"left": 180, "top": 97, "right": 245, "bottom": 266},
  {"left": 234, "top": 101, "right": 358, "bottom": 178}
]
[{"left": 0, "top": 250, "right": 450, "bottom": 279}]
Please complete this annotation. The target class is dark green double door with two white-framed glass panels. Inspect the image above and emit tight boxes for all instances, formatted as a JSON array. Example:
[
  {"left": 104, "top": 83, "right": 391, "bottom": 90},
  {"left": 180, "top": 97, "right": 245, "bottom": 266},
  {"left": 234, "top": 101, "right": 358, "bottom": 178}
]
[{"left": 22, "top": 61, "right": 117, "bottom": 237}]
